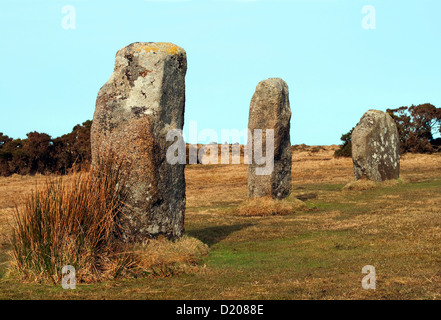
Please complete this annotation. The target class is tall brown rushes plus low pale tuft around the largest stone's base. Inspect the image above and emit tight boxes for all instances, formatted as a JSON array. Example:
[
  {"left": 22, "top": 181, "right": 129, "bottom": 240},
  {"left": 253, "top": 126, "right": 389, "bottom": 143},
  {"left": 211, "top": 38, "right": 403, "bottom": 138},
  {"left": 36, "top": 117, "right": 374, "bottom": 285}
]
[{"left": 10, "top": 158, "right": 208, "bottom": 283}]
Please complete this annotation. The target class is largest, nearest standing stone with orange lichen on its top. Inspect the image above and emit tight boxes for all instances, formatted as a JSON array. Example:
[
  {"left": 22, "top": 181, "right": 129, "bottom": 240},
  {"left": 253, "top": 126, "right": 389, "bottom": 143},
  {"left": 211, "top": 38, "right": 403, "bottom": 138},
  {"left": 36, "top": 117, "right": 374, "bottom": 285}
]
[{"left": 91, "top": 42, "right": 187, "bottom": 242}]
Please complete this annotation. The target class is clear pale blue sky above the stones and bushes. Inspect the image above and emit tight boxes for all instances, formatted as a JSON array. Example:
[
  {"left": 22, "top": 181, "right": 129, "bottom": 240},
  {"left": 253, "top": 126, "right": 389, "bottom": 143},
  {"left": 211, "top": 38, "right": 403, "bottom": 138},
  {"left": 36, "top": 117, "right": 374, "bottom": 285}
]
[{"left": 0, "top": 0, "right": 441, "bottom": 145}]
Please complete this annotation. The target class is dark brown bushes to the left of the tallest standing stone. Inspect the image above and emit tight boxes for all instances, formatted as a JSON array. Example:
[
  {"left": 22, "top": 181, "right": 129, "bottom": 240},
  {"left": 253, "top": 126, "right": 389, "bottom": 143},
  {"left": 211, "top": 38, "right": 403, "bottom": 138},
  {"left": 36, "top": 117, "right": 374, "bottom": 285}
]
[{"left": 0, "top": 120, "right": 92, "bottom": 176}]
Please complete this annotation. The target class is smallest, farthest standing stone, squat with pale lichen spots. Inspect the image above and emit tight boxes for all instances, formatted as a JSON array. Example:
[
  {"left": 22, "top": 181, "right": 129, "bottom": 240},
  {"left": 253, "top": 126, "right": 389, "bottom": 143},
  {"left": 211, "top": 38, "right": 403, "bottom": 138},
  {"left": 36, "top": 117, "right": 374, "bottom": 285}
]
[{"left": 351, "top": 110, "right": 400, "bottom": 181}]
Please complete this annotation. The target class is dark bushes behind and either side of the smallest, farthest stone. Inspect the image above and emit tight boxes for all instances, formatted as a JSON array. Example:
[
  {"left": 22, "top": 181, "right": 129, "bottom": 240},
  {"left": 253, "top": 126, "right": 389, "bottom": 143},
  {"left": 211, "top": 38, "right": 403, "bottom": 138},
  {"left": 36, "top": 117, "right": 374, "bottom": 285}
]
[{"left": 334, "top": 103, "right": 441, "bottom": 157}]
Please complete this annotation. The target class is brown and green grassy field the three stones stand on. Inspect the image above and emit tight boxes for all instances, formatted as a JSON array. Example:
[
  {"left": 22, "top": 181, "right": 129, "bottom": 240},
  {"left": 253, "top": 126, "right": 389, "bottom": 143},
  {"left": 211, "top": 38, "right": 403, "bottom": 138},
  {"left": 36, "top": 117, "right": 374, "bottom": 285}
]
[{"left": 0, "top": 146, "right": 441, "bottom": 299}]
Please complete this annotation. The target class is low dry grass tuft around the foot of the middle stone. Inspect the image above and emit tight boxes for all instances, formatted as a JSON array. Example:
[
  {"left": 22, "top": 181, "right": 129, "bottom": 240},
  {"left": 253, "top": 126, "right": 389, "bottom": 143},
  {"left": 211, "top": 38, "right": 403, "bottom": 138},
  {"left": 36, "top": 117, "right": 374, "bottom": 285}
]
[{"left": 237, "top": 197, "right": 306, "bottom": 217}]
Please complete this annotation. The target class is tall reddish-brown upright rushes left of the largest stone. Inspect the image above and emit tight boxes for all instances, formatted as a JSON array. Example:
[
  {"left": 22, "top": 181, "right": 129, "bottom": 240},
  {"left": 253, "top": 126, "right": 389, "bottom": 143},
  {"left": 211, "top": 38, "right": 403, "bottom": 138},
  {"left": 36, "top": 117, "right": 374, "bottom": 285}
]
[{"left": 11, "top": 160, "right": 131, "bottom": 282}]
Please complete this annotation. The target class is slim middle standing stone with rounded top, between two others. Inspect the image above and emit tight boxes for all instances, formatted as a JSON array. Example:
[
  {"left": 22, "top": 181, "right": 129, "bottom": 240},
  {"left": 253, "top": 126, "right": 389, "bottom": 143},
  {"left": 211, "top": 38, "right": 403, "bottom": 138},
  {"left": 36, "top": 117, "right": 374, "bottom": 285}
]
[{"left": 247, "top": 78, "right": 292, "bottom": 199}]
